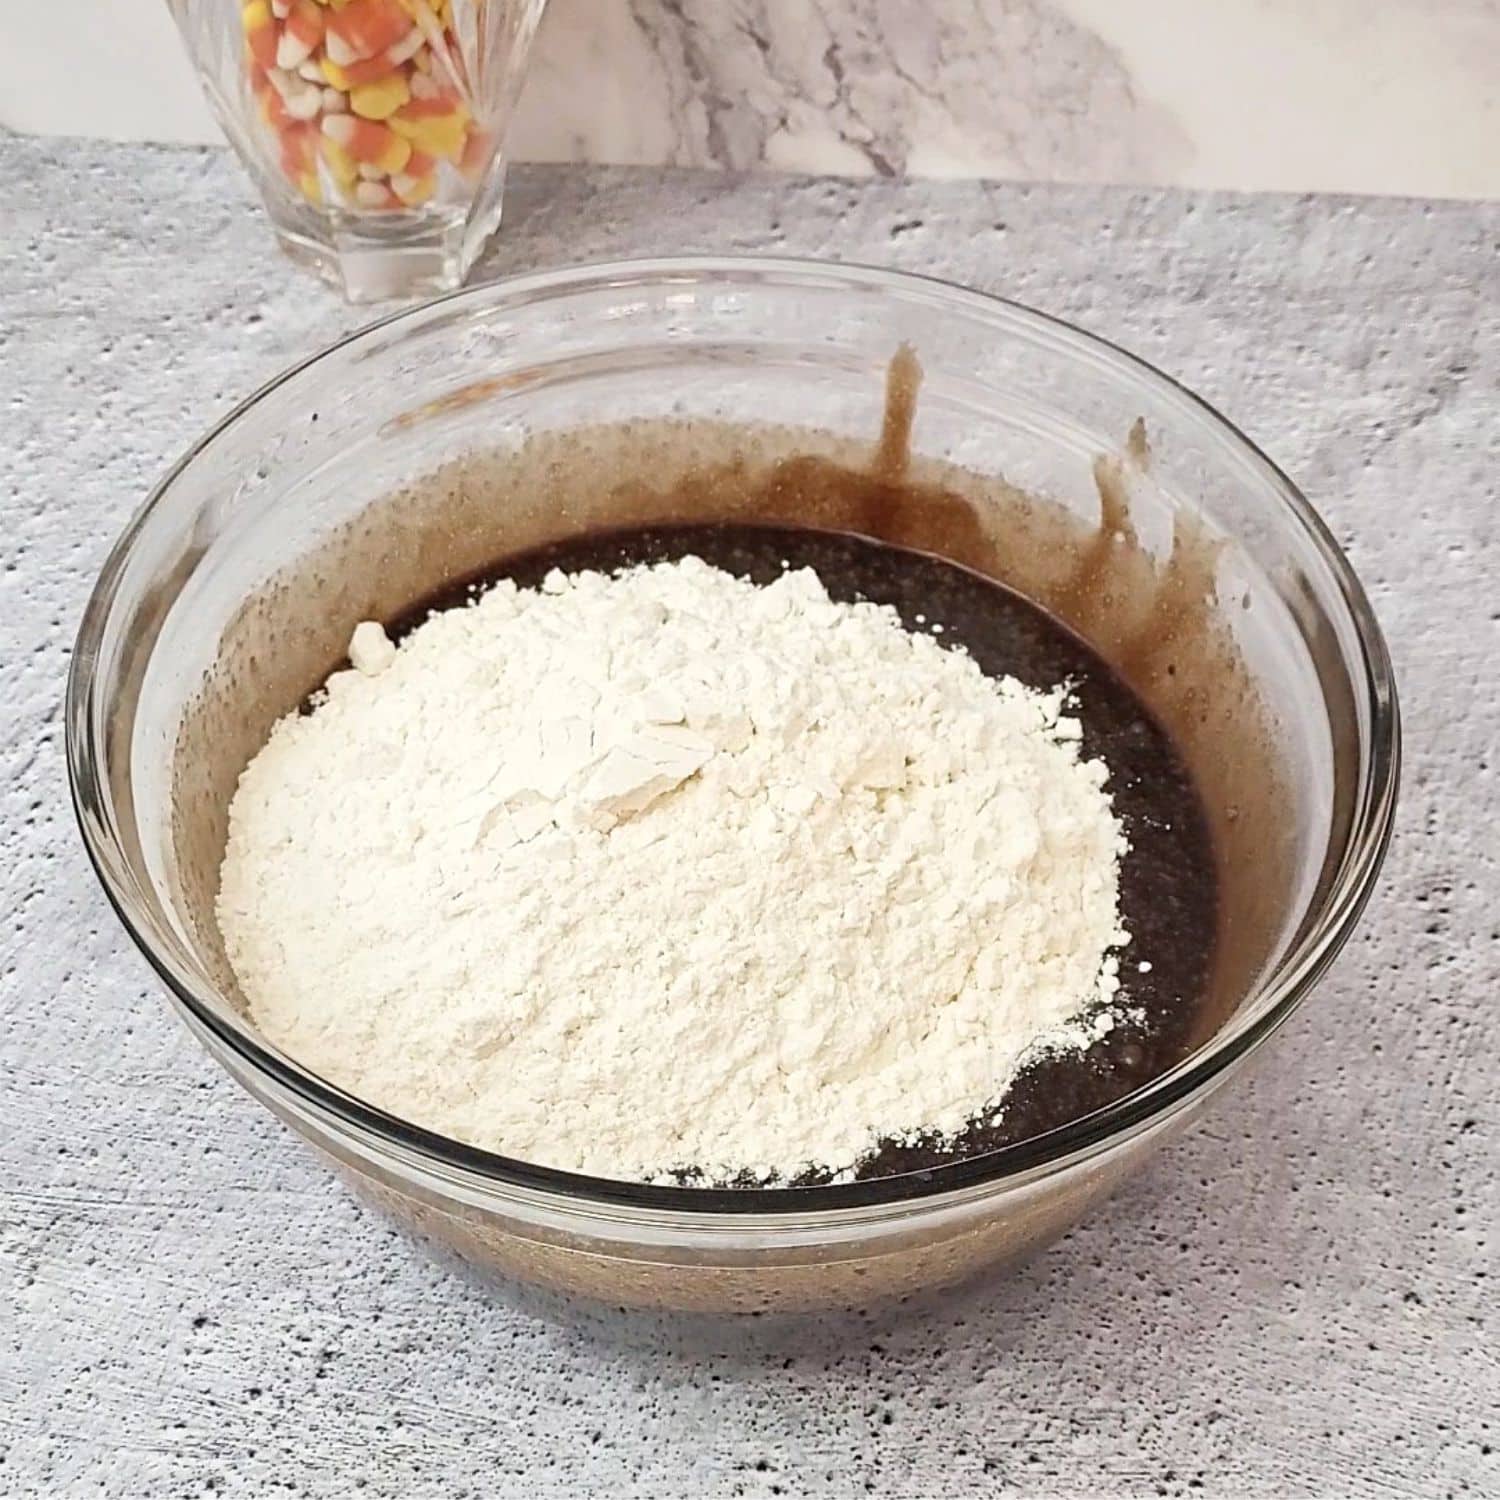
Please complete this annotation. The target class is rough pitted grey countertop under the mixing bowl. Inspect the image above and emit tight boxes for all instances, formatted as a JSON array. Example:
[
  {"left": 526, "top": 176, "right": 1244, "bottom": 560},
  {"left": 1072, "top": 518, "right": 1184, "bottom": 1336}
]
[{"left": 0, "top": 140, "right": 1500, "bottom": 1500}]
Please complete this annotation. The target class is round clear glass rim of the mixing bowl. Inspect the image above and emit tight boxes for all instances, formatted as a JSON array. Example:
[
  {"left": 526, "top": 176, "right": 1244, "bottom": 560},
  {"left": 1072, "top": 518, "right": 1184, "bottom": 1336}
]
[{"left": 65, "top": 255, "right": 1401, "bottom": 1223}]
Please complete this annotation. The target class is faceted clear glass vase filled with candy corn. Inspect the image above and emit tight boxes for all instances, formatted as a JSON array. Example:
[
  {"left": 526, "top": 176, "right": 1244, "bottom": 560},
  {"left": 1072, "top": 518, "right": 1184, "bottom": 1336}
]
[{"left": 168, "top": 0, "right": 546, "bottom": 302}]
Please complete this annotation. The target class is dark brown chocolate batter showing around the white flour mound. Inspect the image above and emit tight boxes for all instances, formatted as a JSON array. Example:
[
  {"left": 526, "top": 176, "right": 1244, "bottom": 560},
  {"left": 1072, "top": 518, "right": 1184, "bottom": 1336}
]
[{"left": 387, "top": 524, "right": 1218, "bottom": 1182}]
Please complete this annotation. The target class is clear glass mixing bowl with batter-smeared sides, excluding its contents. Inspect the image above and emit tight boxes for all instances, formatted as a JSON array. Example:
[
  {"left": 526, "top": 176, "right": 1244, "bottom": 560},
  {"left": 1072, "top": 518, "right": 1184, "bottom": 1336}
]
[{"left": 68, "top": 260, "right": 1400, "bottom": 1310}]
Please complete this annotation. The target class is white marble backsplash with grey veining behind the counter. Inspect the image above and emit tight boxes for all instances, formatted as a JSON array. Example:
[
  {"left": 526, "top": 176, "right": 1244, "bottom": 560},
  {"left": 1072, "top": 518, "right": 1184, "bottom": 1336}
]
[{"left": 0, "top": 0, "right": 1500, "bottom": 198}]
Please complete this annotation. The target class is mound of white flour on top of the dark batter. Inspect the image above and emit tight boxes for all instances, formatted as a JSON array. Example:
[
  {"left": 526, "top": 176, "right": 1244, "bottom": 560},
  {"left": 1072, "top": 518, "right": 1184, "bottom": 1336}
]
[{"left": 219, "top": 558, "right": 1127, "bottom": 1181}]
